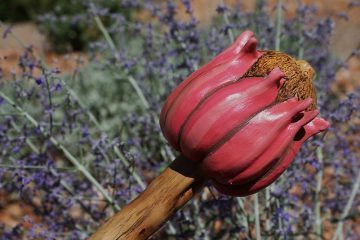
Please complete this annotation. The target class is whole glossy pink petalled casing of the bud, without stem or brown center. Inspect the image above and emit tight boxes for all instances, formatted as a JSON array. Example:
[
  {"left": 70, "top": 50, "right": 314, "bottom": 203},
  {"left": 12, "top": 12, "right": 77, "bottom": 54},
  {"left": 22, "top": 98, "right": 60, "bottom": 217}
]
[{"left": 160, "top": 31, "right": 328, "bottom": 196}]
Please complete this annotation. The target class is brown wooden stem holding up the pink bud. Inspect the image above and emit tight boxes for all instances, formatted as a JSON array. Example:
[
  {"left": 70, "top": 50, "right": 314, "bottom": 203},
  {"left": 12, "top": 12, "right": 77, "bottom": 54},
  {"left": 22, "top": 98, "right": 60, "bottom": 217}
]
[{"left": 90, "top": 156, "right": 206, "bottom": 240}]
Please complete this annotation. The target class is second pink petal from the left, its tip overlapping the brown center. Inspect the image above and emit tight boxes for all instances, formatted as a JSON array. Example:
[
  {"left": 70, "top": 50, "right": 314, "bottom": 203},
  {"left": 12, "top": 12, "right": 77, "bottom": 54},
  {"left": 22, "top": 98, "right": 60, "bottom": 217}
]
[{"left": 179, "top": 68, "right": 284, "bottom": 161}]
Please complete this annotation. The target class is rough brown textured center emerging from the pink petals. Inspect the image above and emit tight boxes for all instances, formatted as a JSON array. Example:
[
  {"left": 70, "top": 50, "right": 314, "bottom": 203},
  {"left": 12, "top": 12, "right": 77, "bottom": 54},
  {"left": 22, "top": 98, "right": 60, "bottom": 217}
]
[{"left": 245, "top": 51, "right": 316, "bottom": 111}]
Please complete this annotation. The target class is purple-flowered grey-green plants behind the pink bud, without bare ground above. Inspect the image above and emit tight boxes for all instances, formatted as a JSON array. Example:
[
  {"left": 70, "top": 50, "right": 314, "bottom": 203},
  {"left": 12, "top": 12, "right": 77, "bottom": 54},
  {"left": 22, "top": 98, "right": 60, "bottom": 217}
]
[{"left": 0, "top": 0, "right": 360, "bottom": 239}]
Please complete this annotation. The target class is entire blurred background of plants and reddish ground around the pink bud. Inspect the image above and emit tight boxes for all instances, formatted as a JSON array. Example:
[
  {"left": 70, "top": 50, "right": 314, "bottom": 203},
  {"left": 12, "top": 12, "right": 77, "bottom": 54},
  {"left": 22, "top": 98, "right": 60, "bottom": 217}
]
[{"left": 0, "top": 0, "right": 360, "bottom": 240}]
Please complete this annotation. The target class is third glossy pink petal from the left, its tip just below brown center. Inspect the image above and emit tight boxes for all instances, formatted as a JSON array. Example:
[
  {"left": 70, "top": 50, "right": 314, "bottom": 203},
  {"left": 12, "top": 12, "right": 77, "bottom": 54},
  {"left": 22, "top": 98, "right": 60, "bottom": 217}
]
[{"left": 202, "top": 99, "right": 312, "bottom": 183}]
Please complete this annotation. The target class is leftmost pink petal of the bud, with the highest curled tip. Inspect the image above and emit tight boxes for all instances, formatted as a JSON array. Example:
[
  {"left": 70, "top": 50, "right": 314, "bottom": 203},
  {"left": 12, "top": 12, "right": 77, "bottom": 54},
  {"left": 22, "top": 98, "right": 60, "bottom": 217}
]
[{"left": 160, "top": 31, "right": 261, "bottom": 151}]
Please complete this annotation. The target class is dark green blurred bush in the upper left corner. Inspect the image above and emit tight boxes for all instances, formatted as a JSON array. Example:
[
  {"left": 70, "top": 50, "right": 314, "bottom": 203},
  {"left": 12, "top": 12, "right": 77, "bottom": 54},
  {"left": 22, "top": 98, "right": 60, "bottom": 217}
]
[{"left": 0, "top": 0, "right": 136, "bottom": 53}]
